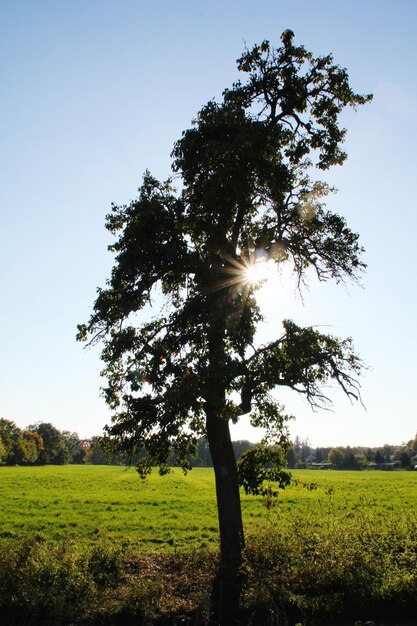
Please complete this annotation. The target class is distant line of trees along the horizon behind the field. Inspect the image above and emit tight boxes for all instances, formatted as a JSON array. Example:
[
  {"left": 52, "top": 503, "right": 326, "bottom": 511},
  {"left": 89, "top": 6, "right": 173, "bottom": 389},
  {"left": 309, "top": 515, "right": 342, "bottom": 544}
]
[{"left": 0, "top": 418, "right": 417, "bottom": 469}]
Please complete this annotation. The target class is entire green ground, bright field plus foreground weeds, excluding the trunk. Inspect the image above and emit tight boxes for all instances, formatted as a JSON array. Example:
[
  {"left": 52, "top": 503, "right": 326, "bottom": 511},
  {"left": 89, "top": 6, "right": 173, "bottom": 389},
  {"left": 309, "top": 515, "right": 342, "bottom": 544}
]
[{"left": 0, "top": 466, "right": 417, "bottom": 626}]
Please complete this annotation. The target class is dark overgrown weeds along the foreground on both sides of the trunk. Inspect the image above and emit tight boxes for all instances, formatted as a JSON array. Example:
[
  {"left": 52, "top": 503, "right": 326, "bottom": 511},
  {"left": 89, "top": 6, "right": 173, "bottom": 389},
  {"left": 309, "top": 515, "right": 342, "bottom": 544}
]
[{"left": 0, "top": 496, "right": 417, "bottom": 626}]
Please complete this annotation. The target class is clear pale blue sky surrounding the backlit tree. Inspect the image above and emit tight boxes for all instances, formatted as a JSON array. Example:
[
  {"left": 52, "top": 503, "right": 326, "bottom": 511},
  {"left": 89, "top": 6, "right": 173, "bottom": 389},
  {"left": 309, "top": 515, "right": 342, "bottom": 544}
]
[{"left": 0, "top": 0, "right": 417, "bottom": 446}]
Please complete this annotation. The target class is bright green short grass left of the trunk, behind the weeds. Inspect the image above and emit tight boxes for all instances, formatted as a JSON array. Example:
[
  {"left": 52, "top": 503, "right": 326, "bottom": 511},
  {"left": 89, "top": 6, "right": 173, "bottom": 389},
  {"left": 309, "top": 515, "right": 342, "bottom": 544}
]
[{"left": 0, "top": 466, "right": 217, "bottom": 549}]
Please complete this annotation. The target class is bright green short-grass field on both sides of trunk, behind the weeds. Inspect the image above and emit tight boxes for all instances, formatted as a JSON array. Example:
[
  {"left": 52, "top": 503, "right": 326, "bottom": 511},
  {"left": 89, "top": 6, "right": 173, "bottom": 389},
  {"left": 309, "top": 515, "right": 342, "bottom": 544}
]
[{"left": 0, "top": 465, "right": 417, "bottom": 551}]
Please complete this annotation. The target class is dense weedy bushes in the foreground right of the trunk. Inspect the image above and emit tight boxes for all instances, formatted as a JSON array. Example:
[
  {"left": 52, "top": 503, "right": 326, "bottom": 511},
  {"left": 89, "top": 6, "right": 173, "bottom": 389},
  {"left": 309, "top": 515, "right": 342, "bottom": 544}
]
[{"left": 240, "top": 505, "right": 417, "bottom": 624}]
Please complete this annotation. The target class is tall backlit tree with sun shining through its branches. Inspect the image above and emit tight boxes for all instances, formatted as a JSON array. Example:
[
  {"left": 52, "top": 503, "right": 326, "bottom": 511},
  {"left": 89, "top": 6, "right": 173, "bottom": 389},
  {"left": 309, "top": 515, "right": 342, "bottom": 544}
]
[{"left": 78, "top": 31, "right": 371, "bottom": 619}]
